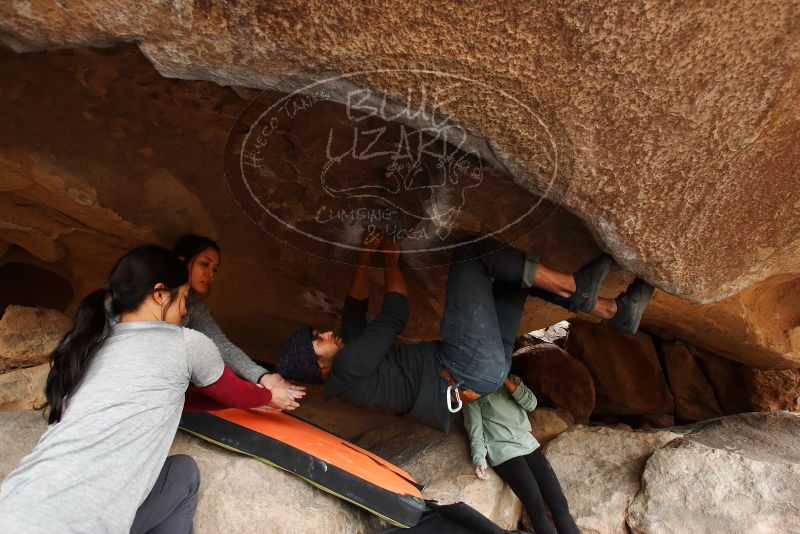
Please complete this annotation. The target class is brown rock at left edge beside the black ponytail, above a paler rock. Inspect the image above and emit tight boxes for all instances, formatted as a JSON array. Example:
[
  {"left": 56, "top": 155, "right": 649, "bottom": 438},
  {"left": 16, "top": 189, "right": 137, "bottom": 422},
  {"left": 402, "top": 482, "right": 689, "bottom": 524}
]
[{"left": 0, "top": 305, "right": 72, "bottom": 372}]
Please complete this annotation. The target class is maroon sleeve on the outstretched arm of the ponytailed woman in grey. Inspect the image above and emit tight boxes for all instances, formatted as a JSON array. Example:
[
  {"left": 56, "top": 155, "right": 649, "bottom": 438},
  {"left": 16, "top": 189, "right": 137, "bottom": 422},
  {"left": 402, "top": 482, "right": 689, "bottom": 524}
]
[{"left": 183, "top": 365, "right": 272, "bottom": 412}]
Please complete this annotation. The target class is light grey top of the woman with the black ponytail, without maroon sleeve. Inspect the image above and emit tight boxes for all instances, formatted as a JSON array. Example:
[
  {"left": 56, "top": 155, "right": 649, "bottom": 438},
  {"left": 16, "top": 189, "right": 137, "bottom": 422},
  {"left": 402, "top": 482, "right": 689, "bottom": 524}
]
[{"left": 0, "top": 321, "right": 223, "bottom": 534}]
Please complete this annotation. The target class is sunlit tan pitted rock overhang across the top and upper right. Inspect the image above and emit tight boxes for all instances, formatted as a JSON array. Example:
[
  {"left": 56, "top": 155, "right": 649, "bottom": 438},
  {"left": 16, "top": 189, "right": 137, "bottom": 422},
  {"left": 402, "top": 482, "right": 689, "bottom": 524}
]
[{"left": 0, "top": 0, "right": 800, "bottom": 306}]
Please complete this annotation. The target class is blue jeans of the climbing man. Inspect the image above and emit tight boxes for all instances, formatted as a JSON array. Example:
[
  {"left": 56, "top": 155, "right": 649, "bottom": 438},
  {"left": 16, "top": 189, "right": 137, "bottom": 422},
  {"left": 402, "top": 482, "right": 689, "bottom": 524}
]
[{"left": 440, "top": 239, "right": 537, "bottom": 395}]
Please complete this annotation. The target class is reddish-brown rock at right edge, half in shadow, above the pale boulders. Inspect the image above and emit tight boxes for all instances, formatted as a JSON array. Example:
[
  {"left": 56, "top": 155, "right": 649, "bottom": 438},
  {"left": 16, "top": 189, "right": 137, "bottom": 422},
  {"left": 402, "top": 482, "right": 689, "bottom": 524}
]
[{"left": 691, "top": 347, "right": 800, "bottom": 414}]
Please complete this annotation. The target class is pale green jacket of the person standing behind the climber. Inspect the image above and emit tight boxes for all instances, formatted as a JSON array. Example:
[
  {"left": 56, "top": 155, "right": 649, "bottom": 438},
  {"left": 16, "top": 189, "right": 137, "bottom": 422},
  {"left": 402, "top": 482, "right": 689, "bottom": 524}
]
[{"left": 463, "top": 375, "right": 539, "bottom": 467}]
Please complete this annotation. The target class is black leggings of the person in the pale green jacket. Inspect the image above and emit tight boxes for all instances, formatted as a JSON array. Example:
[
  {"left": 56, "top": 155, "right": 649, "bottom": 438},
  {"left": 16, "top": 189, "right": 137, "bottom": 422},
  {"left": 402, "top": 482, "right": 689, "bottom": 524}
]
[{"left": 494, "top": 449, "right": 580, "bottom": 534}]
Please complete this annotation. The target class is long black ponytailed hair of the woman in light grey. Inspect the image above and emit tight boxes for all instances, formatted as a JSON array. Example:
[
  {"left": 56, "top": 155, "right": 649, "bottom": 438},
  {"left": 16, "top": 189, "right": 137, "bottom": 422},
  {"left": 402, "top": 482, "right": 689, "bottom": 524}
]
[{"left": 45, "top": 245, "right": 188, "bottom": 424}]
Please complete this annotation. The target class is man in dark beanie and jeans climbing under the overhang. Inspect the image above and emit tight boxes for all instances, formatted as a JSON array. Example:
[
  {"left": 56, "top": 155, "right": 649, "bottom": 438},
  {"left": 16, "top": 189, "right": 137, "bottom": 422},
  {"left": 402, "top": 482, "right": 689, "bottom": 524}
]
[{"left": 277, "top": 232, "right": 653, "bottom": 432}]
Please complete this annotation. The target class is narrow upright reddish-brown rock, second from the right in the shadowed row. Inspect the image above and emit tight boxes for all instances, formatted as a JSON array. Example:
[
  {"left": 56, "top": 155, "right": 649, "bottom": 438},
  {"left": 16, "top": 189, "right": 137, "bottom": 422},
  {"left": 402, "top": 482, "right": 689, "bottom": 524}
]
[{"left": 661, "top": 342, "right": 722, "bottom": 422}]
